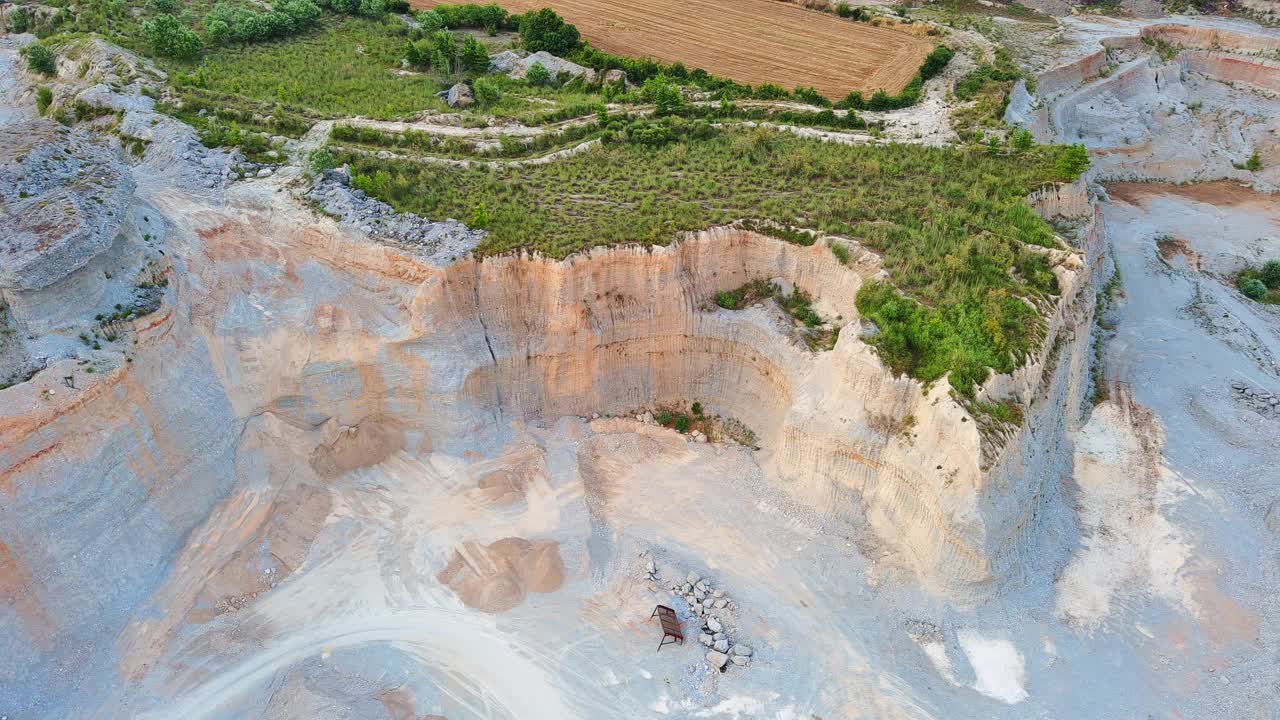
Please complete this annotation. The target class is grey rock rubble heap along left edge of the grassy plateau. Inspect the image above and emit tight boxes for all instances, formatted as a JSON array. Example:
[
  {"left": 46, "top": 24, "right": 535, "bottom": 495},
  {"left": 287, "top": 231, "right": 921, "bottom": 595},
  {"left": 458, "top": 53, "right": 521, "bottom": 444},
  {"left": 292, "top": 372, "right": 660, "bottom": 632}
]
[{"left": 306, "top": 168, "right": 485, "bottom": 259}]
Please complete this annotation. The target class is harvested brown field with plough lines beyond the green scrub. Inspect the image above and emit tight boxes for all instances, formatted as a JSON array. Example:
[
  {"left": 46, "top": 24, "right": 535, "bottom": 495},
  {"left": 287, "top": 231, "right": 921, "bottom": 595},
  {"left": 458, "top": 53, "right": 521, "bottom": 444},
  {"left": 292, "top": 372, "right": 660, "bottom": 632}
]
[{"left": 412, "top": 0, "right": 933, "bottom": 99}]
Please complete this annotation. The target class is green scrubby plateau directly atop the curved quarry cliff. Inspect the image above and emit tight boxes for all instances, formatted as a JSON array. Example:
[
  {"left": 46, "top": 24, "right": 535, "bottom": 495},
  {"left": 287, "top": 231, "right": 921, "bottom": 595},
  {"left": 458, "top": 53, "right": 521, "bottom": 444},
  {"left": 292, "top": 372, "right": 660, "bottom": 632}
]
[{"left": 335, "top": 124, "right": 1087, "bottom": 395}]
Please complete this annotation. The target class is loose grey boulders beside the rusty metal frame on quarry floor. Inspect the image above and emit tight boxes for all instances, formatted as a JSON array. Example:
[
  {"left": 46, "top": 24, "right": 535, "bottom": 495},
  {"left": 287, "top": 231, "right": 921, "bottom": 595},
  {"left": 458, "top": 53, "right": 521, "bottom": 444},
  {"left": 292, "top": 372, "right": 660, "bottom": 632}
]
[{"left": 640, "top": 560, "right": 755, "bottom": 673}]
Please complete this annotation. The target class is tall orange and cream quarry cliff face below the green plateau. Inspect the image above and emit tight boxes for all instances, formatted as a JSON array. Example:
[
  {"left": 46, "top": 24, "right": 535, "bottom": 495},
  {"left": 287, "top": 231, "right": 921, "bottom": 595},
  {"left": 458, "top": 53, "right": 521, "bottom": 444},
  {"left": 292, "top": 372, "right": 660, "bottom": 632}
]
[{"left": 0, "top": 162, "right": 1097, "bottom": 655}]
